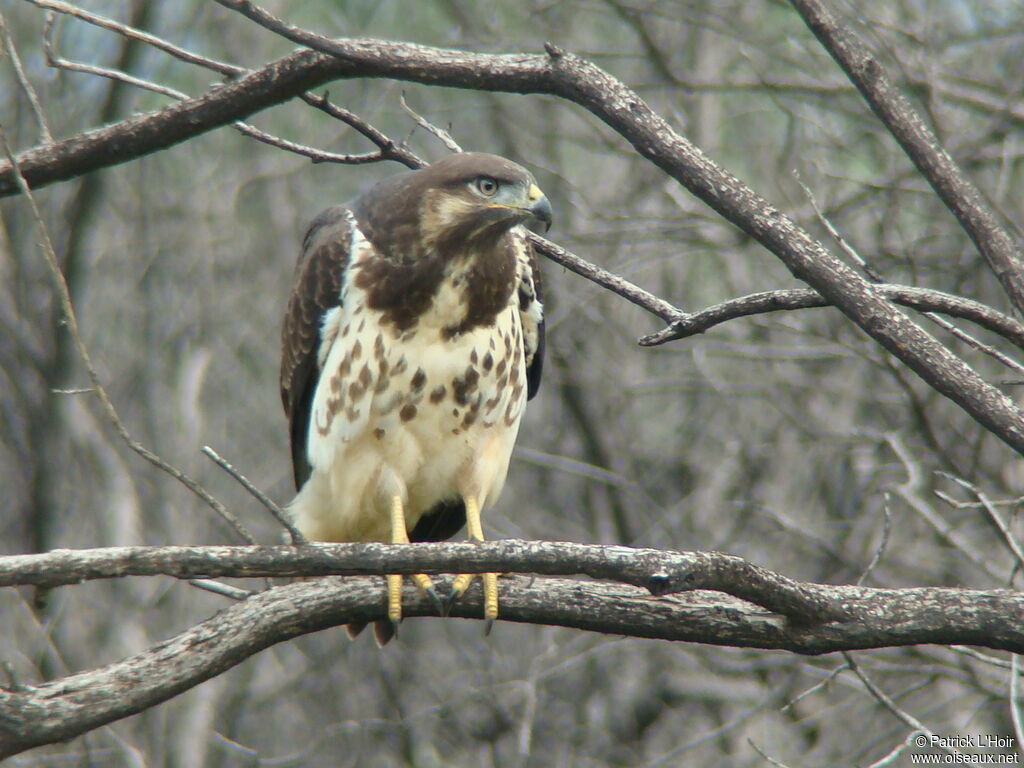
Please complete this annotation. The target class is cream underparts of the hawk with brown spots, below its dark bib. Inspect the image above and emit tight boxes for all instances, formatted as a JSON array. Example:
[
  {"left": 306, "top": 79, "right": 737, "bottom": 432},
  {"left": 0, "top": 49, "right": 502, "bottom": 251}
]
[{"left": 295, "top": 234, "right": 526, "bottom": 541}]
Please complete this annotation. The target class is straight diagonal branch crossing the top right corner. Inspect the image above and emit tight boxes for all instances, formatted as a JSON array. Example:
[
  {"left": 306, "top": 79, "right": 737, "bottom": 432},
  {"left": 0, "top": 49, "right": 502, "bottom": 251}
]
[{"left": 791, "top": 0, "right": 1024, "bottom": 312}]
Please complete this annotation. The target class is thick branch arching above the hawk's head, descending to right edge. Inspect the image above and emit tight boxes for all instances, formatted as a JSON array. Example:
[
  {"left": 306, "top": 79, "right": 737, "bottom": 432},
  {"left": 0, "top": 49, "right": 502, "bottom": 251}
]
[{"left": 8, "top": 25, "right": 1024, "bottom": 454}]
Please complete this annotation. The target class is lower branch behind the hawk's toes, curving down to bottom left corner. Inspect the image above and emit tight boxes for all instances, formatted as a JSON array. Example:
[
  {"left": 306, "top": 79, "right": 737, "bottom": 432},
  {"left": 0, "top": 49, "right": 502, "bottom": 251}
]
[{"left": 0, "top": 577, "right": 1024, "bottom": 758}]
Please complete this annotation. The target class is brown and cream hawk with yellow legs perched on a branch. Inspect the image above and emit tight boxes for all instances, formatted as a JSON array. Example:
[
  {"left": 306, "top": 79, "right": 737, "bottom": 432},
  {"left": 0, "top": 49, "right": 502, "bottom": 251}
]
[{"left": 281, "top": 153, "right": 551, "bottom": 642}]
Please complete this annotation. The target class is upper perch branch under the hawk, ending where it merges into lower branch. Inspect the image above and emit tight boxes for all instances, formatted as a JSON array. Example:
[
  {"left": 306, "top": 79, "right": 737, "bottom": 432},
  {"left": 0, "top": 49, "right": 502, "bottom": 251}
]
[{"left": 0, "top": 540, "right": 845, "bottom": 622}]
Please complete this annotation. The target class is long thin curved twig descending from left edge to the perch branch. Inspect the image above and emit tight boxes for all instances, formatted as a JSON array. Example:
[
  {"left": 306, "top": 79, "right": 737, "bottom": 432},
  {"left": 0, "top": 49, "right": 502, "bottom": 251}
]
[{"left": 0, "top": 124, "right": 256, "bottom": 544}]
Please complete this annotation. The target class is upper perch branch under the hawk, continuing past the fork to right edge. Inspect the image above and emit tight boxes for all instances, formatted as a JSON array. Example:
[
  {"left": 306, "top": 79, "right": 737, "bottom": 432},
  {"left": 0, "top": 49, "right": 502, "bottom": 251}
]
[{"left": 0, "top": 540, "right": 1024, "bottom": 653}]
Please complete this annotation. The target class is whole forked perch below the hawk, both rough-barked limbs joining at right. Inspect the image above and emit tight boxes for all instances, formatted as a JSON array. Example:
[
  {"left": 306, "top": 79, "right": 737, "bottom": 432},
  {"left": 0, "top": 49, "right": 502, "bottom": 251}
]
[{"left": 0, "top": 542, "right": 1024, "bottom": 758}]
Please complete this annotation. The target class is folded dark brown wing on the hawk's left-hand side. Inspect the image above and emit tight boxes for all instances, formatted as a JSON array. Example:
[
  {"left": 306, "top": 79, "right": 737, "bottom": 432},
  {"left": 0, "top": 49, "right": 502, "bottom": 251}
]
[{"left": 281, "top": 206, "right": 354, "bottom": 489}]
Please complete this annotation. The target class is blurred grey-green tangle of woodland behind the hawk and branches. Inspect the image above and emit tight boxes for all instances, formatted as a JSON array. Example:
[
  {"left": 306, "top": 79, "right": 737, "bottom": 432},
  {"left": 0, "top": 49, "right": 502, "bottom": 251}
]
[{"left": 0, "top": 0, "right": 1024, "bottom": 768}]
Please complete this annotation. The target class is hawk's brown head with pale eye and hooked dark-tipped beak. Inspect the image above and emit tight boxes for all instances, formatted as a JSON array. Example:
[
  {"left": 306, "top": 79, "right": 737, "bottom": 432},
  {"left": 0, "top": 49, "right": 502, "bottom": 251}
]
[{"left": 417, "top": 153, "right": 552, "bottom": 254}]
